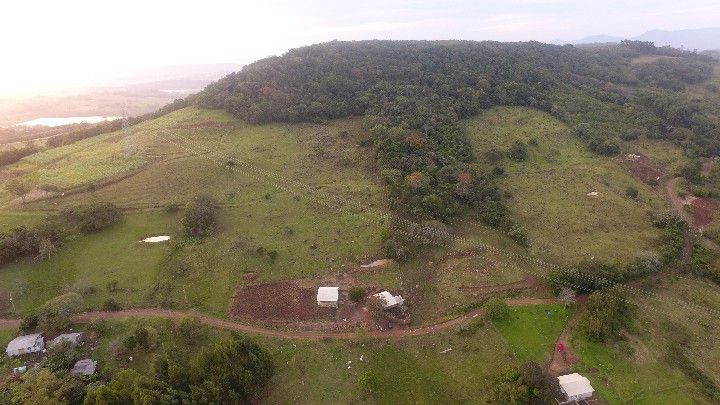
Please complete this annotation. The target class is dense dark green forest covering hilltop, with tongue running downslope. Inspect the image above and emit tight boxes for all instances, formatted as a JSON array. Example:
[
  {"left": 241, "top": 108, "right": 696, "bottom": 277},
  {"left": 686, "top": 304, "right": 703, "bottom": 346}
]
[{"left": 189, "top": 41, "right": 720, "bottom": 248}]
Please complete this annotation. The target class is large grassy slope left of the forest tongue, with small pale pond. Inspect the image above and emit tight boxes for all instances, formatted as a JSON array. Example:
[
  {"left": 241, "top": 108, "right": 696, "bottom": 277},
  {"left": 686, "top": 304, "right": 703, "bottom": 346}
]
[{"left": 0, "top": 109, "right": 387, "bottom": 315}]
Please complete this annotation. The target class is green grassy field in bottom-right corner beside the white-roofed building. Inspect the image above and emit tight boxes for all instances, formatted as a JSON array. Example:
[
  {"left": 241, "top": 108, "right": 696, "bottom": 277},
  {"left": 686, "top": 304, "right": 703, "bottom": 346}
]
[{"left": 572, "top": 277, "right": 720, "bottom": 404}]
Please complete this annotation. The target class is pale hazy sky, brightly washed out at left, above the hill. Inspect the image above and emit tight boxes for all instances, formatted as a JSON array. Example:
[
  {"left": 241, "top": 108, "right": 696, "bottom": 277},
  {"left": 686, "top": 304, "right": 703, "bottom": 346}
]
[{"left": 0, "top": 0, "right": 720, "bottom": 95}]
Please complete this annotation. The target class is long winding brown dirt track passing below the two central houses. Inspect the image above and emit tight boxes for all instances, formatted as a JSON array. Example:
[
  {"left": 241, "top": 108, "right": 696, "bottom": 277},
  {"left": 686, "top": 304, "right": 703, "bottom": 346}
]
[{"left": 0, "top": 299, "right": 560, "bottom": 340}]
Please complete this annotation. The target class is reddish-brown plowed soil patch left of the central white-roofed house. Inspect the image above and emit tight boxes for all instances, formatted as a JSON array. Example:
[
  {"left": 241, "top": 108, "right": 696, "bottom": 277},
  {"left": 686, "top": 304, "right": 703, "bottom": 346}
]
[{"left": 230, "top": 282, "right": 337, "bottom": 322}]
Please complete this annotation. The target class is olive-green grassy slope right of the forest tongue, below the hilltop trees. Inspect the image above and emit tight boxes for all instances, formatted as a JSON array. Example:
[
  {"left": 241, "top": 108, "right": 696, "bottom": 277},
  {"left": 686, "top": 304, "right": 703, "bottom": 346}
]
[{"left": 466, "top": 107, "right": 666, "bottom": 264}]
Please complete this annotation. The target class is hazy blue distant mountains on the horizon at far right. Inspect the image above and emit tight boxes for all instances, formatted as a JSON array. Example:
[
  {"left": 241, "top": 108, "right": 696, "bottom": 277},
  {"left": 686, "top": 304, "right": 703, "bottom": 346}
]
[{"left": 552, "top": 27, "right": 720, "bottom": 51}]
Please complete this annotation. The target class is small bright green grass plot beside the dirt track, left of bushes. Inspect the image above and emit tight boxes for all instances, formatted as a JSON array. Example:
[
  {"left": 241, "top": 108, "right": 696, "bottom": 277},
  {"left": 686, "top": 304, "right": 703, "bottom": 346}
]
[{"left": 493, "top": 304, "right": 574, "bottom": 363}]
